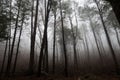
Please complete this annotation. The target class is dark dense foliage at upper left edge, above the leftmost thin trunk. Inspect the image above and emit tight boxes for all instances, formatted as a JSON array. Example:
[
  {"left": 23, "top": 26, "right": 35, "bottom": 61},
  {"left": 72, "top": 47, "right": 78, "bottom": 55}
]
[{"left": 0, "top": 0, "right": 10, "bottom": 41}]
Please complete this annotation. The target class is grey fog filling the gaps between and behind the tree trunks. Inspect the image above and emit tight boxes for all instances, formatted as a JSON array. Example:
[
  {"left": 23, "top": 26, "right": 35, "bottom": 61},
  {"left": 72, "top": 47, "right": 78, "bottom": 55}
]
[{"left": 0, "top": 0, "right": 120, "bottom": 78}]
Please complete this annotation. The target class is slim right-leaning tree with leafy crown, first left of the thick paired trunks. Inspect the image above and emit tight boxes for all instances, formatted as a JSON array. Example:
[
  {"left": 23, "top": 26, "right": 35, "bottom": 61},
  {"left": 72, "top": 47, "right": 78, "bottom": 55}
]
[{"left": 12, "top": 0, "right": 30, "bottom": 74}]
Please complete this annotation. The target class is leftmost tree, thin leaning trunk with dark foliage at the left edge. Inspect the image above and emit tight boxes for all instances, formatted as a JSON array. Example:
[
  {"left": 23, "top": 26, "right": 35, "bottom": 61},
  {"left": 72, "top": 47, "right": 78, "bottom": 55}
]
[{"left": 0, "top": 0, "right": 11, "bottom": 76}]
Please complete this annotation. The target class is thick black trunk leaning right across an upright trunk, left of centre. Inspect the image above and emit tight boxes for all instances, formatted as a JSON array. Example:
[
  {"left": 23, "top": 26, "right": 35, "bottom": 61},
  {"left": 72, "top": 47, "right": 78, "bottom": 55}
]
[{"left": 37, "top": 0, "right": 51, "bottom": 76}]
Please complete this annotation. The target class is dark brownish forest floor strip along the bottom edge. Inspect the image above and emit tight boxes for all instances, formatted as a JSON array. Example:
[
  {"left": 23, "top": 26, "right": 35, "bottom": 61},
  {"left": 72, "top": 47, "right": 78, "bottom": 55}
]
[{"left": 0, "top": 75, "right": 120, "bottom": 80}]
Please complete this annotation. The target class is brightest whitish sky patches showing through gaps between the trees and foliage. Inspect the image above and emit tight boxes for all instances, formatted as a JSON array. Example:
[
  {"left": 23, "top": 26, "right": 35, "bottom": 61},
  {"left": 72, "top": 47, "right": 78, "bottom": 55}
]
[{"left": 8, "top": 0, "right": 117, "bottom": 53}]
